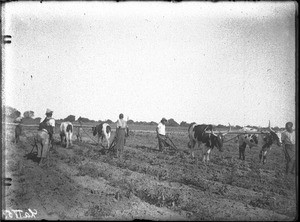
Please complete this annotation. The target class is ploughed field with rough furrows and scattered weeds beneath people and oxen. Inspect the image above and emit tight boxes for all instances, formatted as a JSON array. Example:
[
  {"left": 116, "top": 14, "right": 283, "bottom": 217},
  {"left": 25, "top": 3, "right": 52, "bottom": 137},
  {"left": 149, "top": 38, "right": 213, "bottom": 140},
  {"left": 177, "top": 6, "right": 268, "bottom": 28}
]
[{"left": 2, "top": 126, "right": 296, "bottom": 221}]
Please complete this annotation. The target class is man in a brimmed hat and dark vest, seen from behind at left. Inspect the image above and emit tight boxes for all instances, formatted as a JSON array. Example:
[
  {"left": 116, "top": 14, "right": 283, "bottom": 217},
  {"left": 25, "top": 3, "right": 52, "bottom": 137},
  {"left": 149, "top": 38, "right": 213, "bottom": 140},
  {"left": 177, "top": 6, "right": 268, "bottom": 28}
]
[{"left": 37, "top": 109, "right": 55, "bottom": 165}]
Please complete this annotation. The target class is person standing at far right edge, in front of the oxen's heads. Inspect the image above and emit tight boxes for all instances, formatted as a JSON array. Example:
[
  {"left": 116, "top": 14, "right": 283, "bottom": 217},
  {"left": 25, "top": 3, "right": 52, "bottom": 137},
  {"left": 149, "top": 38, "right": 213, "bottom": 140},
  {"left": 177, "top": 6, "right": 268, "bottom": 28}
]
[{"left": 281, "top": 122, "right": 296, "bottom": 174}]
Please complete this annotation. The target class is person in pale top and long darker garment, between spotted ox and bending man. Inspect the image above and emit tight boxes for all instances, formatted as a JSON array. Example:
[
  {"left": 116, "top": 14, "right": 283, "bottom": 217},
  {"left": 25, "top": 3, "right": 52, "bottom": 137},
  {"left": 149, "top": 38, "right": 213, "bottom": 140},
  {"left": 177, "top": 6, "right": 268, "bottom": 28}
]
[{"left": 116, "top": 113, "right": 127, "bottom": 158}]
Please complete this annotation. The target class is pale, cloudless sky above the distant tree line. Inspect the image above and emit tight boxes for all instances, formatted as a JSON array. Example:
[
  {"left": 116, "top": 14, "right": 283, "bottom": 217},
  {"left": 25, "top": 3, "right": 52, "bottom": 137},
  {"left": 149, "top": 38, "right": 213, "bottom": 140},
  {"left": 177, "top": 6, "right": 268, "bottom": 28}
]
[{"left": 2, "top": 1, "right": 297, "bottom": 127}]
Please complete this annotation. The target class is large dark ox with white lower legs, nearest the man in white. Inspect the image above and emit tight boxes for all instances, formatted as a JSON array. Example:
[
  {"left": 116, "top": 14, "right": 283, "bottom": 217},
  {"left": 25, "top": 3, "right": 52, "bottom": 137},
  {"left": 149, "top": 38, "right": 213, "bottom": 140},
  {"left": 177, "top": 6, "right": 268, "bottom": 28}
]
[{"left": 188, "top": 123, "right": 227, "bottom": 162}]
